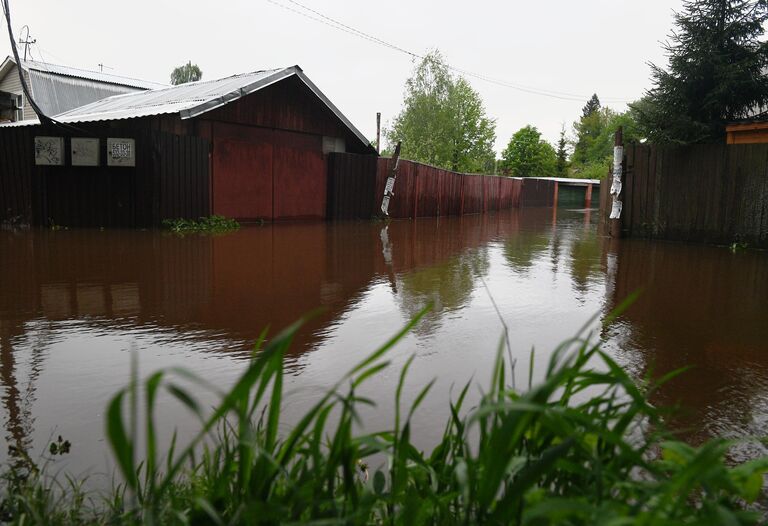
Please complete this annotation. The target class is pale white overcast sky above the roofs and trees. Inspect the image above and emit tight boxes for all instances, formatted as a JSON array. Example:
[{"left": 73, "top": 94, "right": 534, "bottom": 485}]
[{"left": 0, "top": 0, "right": 681, "bottom": 151}]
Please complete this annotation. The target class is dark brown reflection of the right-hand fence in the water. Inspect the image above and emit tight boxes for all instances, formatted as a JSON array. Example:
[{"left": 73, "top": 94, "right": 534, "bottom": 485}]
[{"left": 609, "top": 240, "right": 768, "bottom": 462}]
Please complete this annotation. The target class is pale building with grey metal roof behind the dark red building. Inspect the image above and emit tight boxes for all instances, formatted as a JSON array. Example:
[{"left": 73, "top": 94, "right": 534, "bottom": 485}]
[{"left": 0, "top": 57, "right": 165, "bottom": 122}]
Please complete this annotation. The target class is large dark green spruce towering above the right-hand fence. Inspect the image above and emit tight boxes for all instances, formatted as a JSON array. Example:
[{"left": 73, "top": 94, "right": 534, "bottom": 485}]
[{"left": 632, "top": 0, "right": 768, "bottom": 144}]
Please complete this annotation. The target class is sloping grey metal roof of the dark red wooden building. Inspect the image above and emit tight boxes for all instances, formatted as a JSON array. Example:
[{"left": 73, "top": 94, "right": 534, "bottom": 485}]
[{"left": 9, "top": 66, "right": 369, "bottom": 150}]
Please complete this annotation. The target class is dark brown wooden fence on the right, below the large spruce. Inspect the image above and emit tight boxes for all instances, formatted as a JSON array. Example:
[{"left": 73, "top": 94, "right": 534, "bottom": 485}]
[{"left": 616, "top": 144, "right": 768, "bottom": 247}]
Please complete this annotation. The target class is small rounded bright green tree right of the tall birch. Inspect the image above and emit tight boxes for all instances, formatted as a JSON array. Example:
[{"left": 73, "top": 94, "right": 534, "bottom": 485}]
[{"left": 501, "top": 125, "right": 557, "bottom": 177}]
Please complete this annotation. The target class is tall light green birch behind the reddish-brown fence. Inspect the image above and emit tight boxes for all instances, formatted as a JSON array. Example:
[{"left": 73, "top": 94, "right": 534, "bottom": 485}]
[{"left": 385, "top": 51, "right": 496, "bottom": 172}]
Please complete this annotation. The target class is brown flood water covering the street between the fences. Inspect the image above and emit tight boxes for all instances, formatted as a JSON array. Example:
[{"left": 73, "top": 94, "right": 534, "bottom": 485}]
[{"left": 0, "top": 208, "right": 768, "bottom": 484}]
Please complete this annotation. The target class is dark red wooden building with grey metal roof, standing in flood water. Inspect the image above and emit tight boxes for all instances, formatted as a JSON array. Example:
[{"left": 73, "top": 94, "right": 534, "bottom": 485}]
[{"left": 0, "top": 66, "right": 376, "bottom": 227}]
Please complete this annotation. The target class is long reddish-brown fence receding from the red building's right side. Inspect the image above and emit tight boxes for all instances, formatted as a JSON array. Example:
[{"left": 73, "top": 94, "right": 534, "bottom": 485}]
[{"left": 327, "top": 153, "right": 557, "bottom": 219}]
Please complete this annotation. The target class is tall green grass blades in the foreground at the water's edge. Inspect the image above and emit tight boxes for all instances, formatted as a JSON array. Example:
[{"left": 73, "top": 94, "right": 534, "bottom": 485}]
[{"left": 0, "top": 317, "right": 768, "bottom": 525}]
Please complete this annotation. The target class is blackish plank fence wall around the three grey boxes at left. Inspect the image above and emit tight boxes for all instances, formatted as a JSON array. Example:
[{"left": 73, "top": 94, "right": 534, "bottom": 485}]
[{"left": 0, "top": 127, "right": 210, "bottom": 227}]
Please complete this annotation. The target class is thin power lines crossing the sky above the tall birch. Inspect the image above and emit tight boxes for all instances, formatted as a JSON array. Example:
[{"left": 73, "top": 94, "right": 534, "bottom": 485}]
[{"left": 267, "top": 0, "right": 631, "bottom": 102}]
